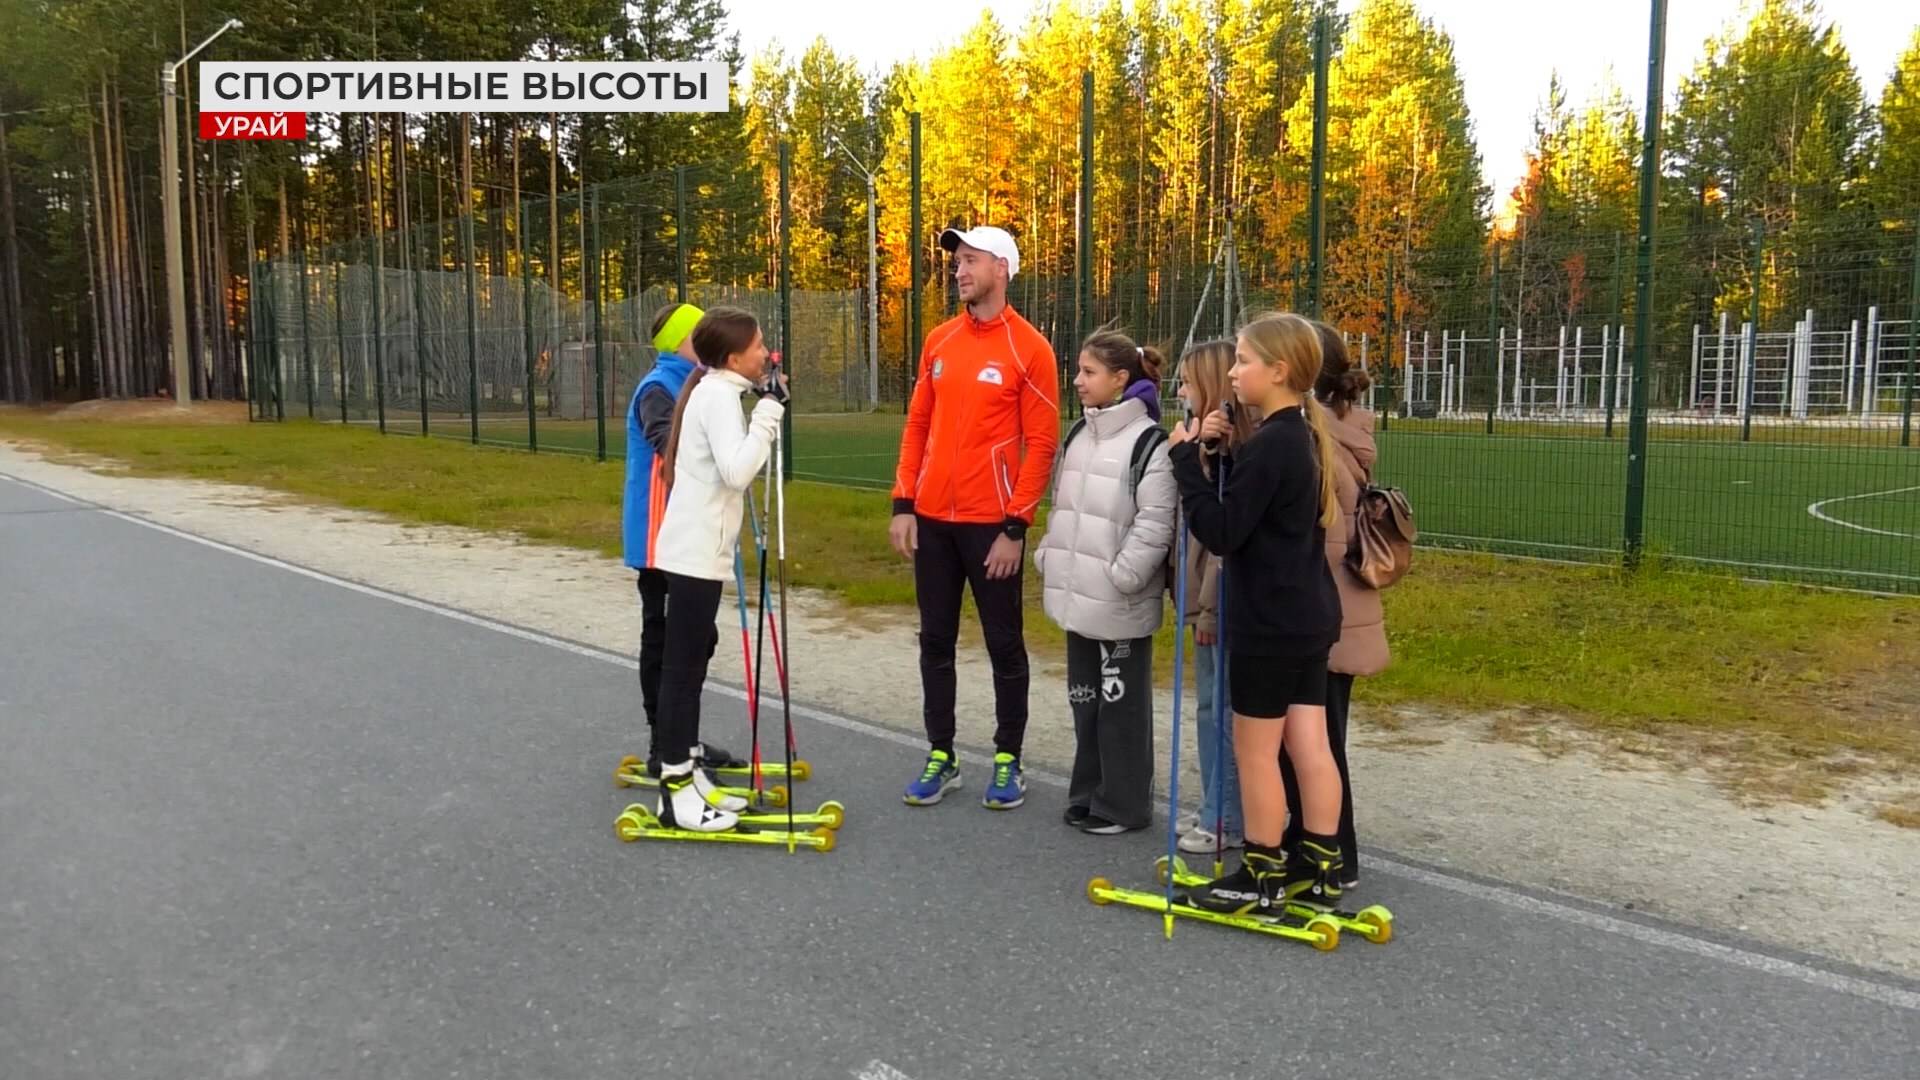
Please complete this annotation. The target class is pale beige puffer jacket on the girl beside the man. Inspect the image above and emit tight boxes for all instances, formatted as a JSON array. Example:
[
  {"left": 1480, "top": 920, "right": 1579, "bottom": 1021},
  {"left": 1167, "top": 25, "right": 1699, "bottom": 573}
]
[{"left": 1033, "top": 400, "right": 1179, "bottom": 642}]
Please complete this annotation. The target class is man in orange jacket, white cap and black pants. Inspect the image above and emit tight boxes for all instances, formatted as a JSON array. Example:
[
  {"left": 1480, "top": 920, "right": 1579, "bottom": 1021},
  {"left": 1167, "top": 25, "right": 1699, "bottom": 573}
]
[{"left": 891, "top": 225, "right": 1060, "bottom": 809}]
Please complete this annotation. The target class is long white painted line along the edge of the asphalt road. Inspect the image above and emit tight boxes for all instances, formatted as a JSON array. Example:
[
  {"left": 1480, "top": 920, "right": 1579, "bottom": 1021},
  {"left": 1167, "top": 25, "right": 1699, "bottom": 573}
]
[{"left": 0, "top": 473, "right": 1920, "bottom": 1006}]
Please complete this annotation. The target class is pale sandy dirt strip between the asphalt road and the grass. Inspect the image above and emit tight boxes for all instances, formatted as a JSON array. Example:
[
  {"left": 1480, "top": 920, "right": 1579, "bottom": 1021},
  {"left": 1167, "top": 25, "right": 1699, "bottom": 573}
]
[{"left": 0, "top": 442, "right": 1920, "bottom": 976}]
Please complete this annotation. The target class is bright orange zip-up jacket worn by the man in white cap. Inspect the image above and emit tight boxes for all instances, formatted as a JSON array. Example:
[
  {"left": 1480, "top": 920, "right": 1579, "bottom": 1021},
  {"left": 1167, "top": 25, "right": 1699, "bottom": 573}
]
[{"left": 893, "top": 307, "right": 1060, "bottom": 525}]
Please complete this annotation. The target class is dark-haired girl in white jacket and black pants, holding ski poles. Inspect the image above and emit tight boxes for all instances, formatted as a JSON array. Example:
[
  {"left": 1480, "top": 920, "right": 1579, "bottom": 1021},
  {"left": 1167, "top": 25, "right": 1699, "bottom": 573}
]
[{"left": 653, "top": 307, "right": 787, "bottom": 832}]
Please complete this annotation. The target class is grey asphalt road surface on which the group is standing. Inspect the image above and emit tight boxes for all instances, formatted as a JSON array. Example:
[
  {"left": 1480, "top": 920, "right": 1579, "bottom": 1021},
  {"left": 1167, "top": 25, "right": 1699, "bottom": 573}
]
[{"left": 0, "top": 479, "right": 1920, "bottom": 1080}]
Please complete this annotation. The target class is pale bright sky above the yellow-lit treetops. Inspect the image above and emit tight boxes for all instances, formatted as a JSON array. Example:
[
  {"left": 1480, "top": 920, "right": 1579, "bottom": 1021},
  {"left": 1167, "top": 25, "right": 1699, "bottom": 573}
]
[{"left": 726, "top": 0, "right": 1920, "bottom": 208}]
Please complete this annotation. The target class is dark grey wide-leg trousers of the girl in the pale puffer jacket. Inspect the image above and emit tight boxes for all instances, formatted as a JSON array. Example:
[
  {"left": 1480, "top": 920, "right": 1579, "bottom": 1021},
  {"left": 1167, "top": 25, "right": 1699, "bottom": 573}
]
[{"left": 1068, "top": 632, "right": 1154, "bottom": 826}]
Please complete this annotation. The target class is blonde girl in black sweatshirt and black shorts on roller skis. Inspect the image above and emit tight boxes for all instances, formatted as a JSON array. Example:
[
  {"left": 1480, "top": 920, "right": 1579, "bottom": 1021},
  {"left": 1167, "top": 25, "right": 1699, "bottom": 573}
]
[{"left": 1169, "top": 313, "right": 1344, "bottom": 915}]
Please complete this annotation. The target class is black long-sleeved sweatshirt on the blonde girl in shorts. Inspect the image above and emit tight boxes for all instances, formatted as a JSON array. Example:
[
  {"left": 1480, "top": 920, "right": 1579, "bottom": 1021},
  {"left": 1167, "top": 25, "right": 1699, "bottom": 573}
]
[{"left": 1173, "top": 405, "right": 1340, "bottom": 657}]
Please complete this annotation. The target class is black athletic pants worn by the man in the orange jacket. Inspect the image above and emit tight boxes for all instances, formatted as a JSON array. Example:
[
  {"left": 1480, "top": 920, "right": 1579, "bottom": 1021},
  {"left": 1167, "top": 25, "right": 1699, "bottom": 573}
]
[{"left": 914, "top": 517, "right": 1027, "bottom": 757}]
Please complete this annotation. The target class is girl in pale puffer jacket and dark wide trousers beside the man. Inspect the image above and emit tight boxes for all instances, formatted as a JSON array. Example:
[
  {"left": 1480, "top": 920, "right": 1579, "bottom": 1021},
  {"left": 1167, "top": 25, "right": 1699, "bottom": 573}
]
[{"left": 1033, "top": 331, "right": 1177, "bottom": 836}]
